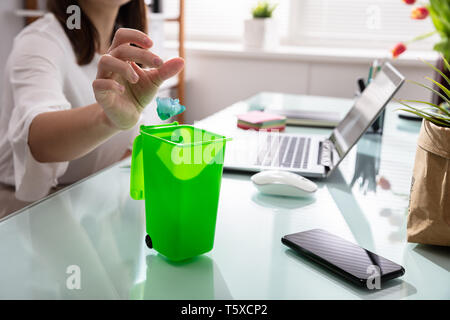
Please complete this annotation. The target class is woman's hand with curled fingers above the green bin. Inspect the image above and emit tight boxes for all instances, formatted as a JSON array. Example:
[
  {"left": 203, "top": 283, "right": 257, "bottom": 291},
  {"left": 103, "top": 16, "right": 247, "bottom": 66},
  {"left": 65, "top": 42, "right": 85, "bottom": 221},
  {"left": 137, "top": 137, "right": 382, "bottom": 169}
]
[{"left": 93, "top": 28, "right": 184, "bottom": 130}]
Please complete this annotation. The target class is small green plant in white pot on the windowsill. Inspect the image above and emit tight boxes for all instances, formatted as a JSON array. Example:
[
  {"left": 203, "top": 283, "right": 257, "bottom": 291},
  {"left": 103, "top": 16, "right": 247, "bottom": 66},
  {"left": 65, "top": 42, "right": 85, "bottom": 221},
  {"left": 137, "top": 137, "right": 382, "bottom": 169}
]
[{"left": 244, "top": 1, "right": 278, "bottom": 49}]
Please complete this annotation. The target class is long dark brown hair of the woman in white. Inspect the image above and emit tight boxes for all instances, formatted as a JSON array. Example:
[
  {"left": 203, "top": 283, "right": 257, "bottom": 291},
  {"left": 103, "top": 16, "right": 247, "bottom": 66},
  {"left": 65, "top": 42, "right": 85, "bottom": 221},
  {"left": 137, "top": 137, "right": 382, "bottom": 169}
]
[{"left": 47, "top": 0, "right": 147, "bottom": 65}]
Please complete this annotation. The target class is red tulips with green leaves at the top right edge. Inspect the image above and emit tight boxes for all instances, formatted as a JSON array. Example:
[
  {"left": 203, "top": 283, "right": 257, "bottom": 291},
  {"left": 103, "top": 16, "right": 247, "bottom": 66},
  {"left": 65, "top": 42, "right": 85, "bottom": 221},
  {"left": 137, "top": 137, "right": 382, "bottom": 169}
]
[{"left": 391, "top": 0, "right": 450, "bottom": 105}]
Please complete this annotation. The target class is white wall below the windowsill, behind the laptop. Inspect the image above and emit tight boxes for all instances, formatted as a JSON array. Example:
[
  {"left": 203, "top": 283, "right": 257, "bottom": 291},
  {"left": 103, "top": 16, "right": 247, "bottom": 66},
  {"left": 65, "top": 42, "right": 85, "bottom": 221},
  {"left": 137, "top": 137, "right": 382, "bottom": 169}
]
[{"left": 185, "top": 49, "right": 433, "bottom": 123}]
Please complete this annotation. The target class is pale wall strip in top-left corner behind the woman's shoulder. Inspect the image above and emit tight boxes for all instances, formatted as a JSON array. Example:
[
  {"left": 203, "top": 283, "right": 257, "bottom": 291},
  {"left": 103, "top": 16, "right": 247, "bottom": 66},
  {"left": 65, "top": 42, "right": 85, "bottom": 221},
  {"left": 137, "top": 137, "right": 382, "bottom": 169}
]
[{"left": 0, "top": 0, "right": 24, "bottom": 101}]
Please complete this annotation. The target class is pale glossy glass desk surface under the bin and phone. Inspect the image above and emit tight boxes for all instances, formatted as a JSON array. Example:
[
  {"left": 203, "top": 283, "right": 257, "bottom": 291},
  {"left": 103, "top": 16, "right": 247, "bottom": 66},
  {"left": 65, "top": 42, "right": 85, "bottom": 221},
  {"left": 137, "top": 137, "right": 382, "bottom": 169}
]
[{"left": 0, "top": 93, "right": 450, "bottom": 299}]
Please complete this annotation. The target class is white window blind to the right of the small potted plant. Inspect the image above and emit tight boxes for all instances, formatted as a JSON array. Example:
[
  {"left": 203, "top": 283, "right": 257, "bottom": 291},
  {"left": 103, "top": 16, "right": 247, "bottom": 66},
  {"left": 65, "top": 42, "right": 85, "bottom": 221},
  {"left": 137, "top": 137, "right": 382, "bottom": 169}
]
[{"left": 291, "top": 0, "right": 435, "bottom": 46}]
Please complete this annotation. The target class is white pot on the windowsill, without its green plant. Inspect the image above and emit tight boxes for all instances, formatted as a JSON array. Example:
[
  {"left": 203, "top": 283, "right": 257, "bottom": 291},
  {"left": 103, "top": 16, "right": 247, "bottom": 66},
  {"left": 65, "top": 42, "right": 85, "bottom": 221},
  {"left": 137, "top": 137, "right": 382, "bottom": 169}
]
[{"left": 244, "top": 18, "right": 278, "bottom": 49}]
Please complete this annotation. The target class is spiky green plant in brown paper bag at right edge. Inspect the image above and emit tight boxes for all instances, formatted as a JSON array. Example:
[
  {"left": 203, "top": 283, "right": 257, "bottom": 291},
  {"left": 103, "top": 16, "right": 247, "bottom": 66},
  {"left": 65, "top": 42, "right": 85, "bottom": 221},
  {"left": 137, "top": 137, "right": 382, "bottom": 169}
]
[{"left": 398, "top": 56, "right": 450, "bottom": 246}]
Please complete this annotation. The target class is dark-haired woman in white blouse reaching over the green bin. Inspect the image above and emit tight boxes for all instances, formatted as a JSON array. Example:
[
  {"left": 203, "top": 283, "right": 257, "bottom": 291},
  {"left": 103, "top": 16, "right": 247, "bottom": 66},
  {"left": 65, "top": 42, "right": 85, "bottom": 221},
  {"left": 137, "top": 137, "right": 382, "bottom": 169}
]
[{"left": 0, "top": 0, "right": 184, "bottom": 217}]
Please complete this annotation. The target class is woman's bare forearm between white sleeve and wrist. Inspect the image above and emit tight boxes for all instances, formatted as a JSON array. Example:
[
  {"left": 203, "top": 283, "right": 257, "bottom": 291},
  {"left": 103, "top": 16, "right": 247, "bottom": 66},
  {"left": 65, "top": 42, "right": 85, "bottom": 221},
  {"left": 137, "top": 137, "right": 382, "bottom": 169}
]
[{"left": 28, "top": 103, "right": 119, "bottom": 162}]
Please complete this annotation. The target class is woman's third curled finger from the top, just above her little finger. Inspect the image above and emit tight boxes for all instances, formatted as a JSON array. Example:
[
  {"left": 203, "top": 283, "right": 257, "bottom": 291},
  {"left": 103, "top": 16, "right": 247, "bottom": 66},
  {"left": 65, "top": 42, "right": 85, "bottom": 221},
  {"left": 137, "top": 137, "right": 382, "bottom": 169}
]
[{"left": 97, "top": 54, "right": 139, "bottom": 83}]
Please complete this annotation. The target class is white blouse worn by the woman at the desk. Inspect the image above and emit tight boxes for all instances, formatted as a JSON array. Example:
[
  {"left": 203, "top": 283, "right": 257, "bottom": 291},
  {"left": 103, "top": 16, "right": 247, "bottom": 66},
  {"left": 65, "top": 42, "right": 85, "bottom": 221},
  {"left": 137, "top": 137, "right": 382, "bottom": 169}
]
[{"left": 0, "top": 13, "right": 151, "bottom": 201}]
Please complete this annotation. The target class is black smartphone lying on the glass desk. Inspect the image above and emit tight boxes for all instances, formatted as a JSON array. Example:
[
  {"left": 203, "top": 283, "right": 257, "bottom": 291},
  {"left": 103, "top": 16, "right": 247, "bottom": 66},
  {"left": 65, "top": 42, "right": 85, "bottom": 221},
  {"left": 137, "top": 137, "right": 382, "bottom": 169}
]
[{"left": 281, "top": 229, "right": 405, "bottom": 287}]
